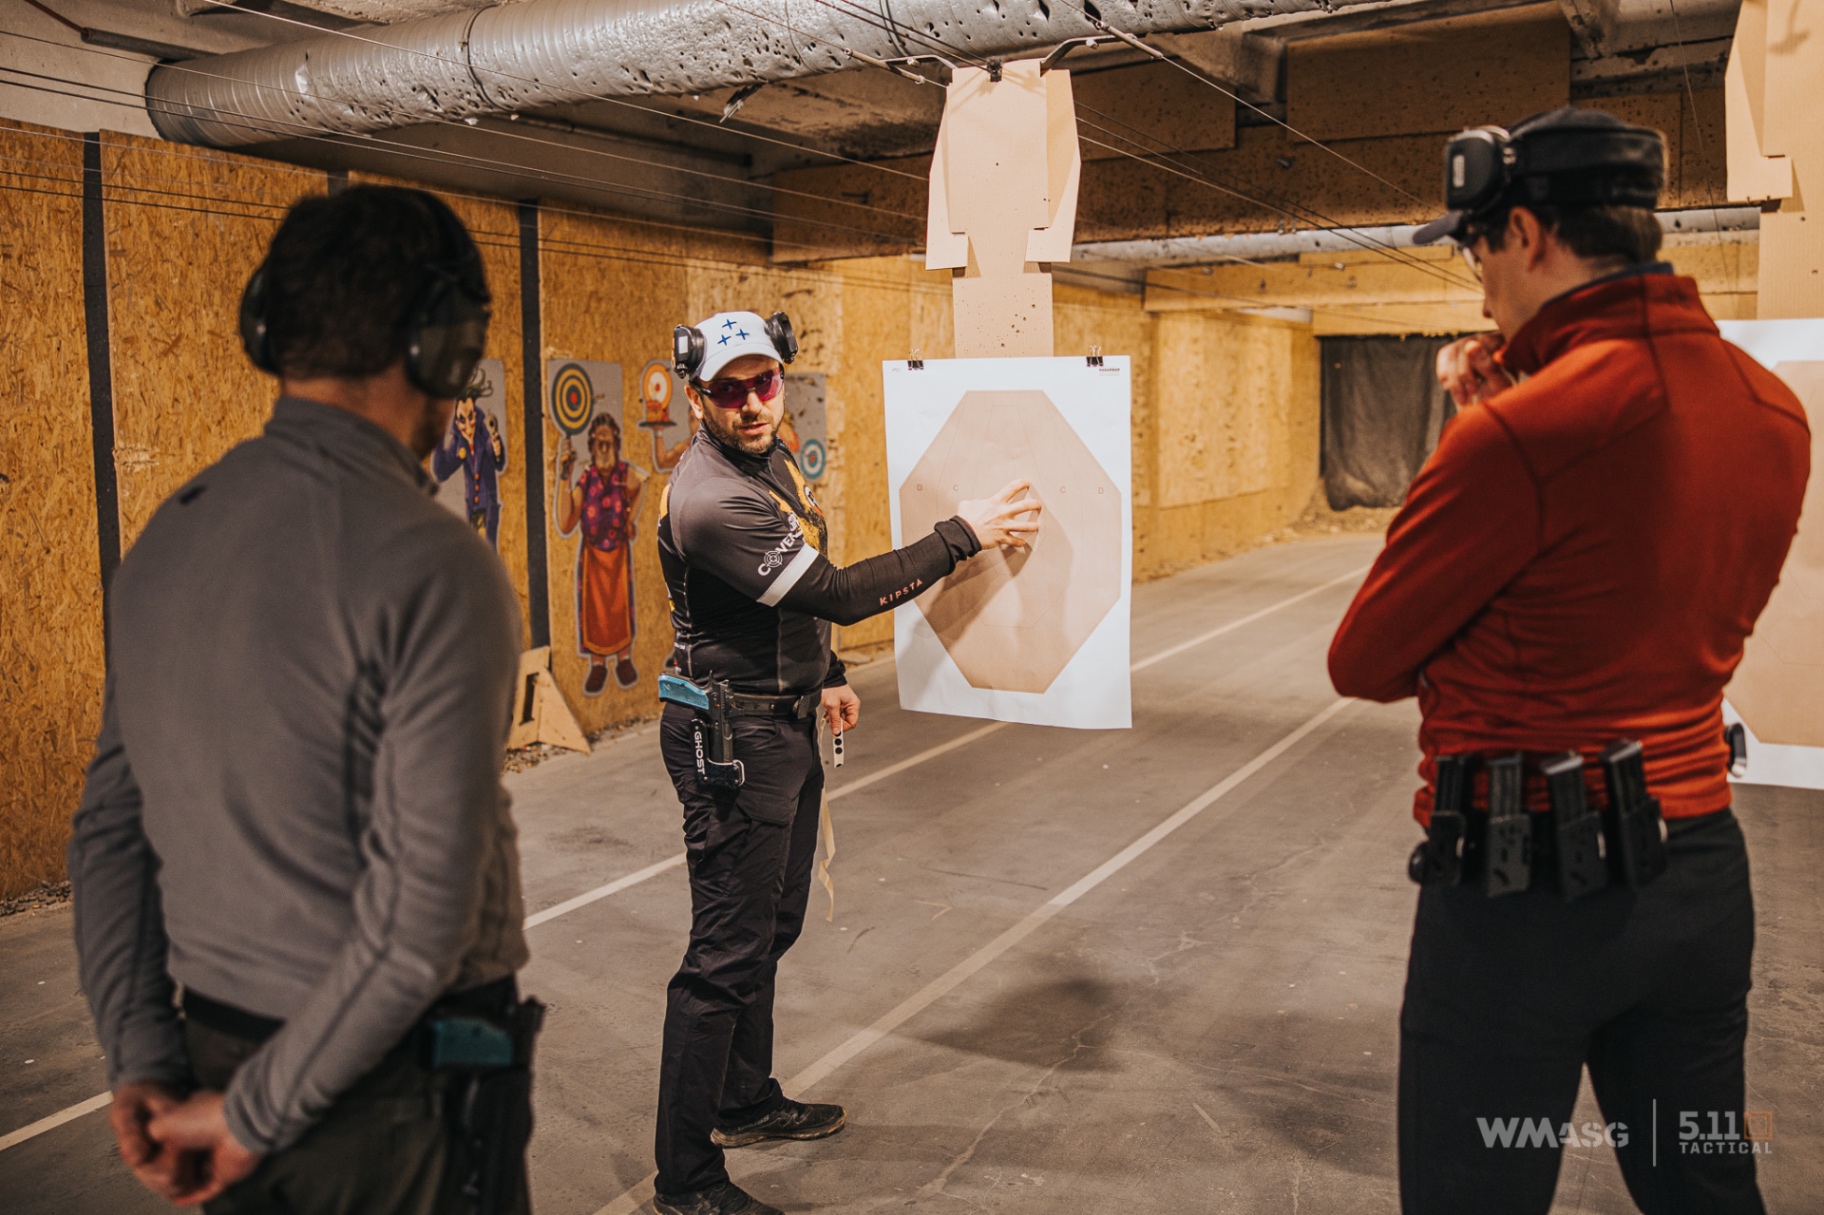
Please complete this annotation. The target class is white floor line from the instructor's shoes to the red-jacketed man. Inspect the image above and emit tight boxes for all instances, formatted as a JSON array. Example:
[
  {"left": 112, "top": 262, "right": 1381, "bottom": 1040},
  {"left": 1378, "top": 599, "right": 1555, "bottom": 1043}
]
[{"left": 595, "top": 689, "right": 1353, "bottom": 1215}]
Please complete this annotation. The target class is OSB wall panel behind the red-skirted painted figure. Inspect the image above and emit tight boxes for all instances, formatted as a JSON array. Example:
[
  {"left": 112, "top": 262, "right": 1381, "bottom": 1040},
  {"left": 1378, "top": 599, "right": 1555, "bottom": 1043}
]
[{"left": 538, "top": 210, "right": 699, "bottom": 733}]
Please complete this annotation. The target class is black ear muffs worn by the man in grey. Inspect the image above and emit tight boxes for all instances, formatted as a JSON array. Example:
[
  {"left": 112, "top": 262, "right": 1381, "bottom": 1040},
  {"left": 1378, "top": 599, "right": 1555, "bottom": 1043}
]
[{"left": 241, "top": 191, "right": 492, "bottom": 400}]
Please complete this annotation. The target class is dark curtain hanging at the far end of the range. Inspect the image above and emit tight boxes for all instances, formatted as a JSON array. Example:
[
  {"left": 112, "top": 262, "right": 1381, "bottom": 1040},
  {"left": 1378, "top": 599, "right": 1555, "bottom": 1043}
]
[{"left": 1321, "top": 338, "right": 1456, "bottom": 511}]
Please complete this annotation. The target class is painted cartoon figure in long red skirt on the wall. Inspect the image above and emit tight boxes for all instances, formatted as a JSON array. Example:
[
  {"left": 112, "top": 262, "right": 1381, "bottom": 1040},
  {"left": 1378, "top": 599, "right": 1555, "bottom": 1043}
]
[{"left": 556, "top": 412, "right": 646, "bottom": 697}]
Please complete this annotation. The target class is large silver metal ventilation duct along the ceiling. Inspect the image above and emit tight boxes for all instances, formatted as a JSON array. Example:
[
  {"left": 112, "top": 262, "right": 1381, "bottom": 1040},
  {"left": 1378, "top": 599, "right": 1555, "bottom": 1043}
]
[{"left": 146, "top": 0, "right": 1333, "bottom": 148}]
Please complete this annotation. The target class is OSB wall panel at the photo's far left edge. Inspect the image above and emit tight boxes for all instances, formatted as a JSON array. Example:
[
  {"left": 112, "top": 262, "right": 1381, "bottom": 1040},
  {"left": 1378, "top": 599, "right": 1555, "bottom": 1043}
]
[{"left": 0, "top": 124, "right": 104, "bottom": 898}]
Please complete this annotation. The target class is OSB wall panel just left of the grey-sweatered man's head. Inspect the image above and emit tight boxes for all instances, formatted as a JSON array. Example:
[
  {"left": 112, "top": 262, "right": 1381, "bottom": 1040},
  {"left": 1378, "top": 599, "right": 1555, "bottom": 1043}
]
[{"left": 102, "top": 133, "right": 326, "bottom": 549}]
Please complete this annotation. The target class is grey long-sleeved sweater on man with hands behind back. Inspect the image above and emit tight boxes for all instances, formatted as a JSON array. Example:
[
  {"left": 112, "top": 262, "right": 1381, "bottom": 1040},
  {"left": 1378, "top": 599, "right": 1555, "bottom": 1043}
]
[{"left": 69, "top": 398, "right": 527, "bottom": 1151}]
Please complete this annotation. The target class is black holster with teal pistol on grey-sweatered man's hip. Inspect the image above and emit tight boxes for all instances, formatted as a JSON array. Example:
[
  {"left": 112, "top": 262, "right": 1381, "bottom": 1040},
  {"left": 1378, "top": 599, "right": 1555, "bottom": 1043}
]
[{"left": 425, "top": 1000, "right": 545, "bottom": 1215}]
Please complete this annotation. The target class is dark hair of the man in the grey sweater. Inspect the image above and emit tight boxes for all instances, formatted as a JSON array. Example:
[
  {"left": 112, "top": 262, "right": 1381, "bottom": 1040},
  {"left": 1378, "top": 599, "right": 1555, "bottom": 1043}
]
[{"left": 266, "top": 186, "right": 489, "bottom": 379}]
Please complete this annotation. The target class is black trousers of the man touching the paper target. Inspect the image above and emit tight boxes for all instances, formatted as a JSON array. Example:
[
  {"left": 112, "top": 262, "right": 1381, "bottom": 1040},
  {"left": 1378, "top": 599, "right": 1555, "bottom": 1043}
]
[{"left": 655, "top": 704, "right": 823, "bottom": 1195}]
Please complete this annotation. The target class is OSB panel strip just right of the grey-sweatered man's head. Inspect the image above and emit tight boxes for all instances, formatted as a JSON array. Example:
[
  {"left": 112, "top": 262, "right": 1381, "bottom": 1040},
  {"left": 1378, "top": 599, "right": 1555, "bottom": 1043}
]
[{"left": 350, "top": 173, "right": 531, "bottom": 646}]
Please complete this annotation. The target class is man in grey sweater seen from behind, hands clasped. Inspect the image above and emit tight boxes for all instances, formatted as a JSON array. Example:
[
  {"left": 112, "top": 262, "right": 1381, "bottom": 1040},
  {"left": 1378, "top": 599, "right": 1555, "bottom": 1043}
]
[{"left": 69, "top": 186, "right": 540, "bottom": 1213}]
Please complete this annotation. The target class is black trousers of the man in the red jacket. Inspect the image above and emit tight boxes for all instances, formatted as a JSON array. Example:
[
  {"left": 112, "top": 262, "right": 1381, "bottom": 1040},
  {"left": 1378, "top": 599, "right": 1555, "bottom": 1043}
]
[{"left": 1399, "top": 810, "right": 1771, "bottom": 1215}]
